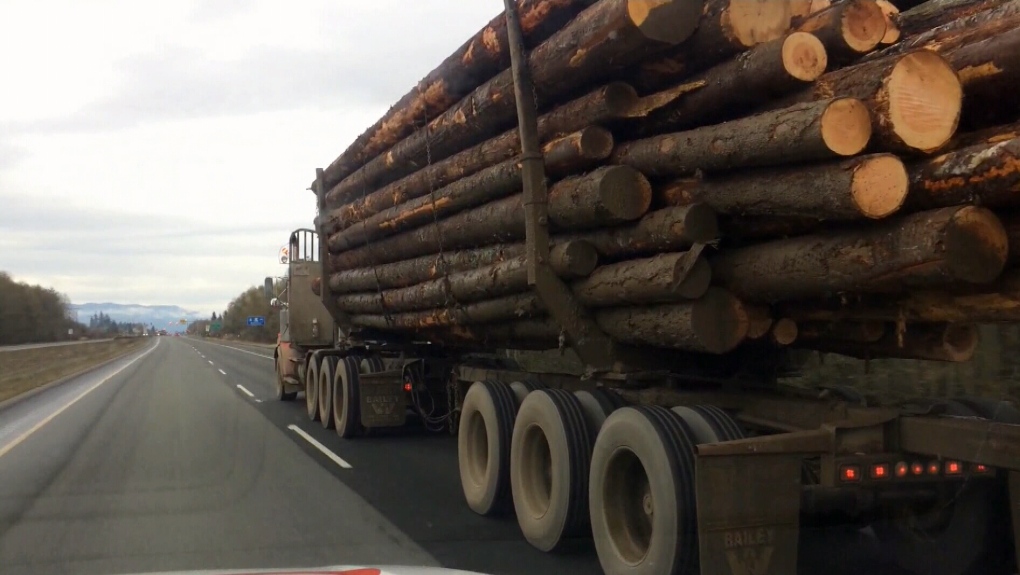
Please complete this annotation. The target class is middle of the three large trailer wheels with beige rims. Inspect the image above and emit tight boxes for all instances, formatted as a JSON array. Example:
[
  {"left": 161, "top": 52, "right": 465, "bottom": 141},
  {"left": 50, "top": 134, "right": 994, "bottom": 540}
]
[{"left": 510, "top": 389, "right": 593, "bottom": 552}]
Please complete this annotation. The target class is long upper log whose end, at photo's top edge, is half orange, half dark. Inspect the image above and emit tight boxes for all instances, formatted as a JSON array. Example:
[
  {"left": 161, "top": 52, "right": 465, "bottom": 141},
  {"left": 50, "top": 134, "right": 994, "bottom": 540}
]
[{"left": 332, "top": 0, "right": 702, "bottom": 205}]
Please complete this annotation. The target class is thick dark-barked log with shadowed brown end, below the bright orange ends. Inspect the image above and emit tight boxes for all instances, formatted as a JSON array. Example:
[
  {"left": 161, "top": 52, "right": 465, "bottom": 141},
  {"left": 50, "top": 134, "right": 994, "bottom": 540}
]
[{"left": 712, "top": 206, "right": 1008, "bottom": 303}]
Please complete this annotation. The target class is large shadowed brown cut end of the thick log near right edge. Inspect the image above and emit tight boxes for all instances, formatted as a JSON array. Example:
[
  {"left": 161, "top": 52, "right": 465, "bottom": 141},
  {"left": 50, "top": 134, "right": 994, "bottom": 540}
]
[{"left": 946, "top": 206, "right": 1009, "bottom": 283}]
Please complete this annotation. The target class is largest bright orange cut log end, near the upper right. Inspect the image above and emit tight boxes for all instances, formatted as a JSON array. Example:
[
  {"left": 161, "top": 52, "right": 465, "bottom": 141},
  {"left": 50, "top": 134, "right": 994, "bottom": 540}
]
[{"left": 886, "top": 50, "right": 963, "bottom": 152}]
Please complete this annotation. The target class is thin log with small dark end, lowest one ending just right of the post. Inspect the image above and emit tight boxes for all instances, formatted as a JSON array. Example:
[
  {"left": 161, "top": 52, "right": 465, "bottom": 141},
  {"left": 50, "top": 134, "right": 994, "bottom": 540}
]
[{"left": 337, "top": 242, "right": 595, "bottom": 314}]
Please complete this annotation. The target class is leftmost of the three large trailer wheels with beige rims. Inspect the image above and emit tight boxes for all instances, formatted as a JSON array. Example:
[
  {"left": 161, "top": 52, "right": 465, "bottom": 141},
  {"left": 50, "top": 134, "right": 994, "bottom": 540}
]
[{"left": 457, "top": 381, "right": 517, "bottom": 515}]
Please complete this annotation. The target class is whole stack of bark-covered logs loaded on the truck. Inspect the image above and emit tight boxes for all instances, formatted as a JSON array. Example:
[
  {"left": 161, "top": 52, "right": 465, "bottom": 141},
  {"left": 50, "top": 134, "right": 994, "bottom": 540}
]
[{"left": 315, "top": 0, "right": 1020, "bottom": 367}]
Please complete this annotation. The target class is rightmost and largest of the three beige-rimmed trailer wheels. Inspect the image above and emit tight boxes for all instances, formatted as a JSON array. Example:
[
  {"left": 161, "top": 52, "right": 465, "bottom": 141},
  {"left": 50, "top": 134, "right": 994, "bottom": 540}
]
[{"left": 589, "top": 406, "right": 698, "bottom": 575}]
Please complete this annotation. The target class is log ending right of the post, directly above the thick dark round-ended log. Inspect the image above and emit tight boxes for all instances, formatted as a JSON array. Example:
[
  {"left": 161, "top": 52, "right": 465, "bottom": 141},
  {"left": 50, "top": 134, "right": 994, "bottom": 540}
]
[{"left": 329, "top": 126, "right": 613, "bottom": 250}]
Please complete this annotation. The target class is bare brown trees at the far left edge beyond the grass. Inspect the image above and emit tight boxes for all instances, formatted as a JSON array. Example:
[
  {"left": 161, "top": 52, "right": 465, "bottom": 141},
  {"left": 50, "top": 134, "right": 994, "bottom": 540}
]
[{"left": 0, "top": 271, "right": 88, "bottom": 346}]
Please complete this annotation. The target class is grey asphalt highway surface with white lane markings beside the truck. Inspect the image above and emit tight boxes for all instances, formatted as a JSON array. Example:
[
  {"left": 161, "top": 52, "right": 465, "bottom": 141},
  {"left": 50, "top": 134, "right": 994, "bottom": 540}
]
[{"left": 0, "top": 337, "right": 600, "bottom": 574}]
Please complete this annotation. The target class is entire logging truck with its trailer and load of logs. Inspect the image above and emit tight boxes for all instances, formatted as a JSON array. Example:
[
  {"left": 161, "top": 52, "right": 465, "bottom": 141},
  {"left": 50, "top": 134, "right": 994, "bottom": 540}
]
[{"left": 265, "top": 0, "right": 1020, "bottom": 575}]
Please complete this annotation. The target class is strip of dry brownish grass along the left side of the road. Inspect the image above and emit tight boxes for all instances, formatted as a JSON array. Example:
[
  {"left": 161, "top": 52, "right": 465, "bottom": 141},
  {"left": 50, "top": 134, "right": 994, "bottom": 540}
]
[{"left": 0, "top": 337, "right": 150, "bottom": 402}]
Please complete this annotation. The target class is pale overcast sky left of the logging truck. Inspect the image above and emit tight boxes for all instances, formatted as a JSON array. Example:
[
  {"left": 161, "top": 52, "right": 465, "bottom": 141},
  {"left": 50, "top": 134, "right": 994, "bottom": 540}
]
[{"left": 0, "top": 0, "right": 503, "bottom": 313}]
